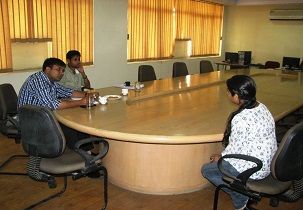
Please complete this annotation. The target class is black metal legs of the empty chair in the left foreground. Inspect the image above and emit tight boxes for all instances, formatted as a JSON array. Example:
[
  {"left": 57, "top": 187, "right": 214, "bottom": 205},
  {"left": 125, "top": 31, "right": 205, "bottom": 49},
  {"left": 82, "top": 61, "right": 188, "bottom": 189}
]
[{"left": 24, "top": 166, "right": 108, "bottom": 210}]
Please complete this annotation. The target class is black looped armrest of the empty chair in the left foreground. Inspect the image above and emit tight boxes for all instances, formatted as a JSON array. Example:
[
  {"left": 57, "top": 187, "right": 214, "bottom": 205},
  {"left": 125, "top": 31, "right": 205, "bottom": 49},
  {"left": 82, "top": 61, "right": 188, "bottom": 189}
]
[{"left": 74, "top": 137, "right": 109, "bottom": 166}]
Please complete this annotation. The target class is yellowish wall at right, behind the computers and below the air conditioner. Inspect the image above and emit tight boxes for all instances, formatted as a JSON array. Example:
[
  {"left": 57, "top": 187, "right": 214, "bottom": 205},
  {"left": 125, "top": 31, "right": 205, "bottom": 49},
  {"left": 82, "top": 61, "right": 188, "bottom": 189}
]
[{"left": 223, "top": 4, "right": 303, "bottom": 64}]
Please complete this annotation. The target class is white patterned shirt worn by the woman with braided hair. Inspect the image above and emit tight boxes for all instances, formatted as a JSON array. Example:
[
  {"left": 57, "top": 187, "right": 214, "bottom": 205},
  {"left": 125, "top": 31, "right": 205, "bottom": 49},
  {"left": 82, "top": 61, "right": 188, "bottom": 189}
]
[{"left": 222, "top": 103, "right": 277, "bottom": 179}]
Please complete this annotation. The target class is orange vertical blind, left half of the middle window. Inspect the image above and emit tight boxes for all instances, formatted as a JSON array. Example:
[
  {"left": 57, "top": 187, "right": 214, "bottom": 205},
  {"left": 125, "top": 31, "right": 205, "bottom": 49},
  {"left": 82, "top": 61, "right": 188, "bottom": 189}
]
[{"left": 128, "top": 0, "right": 174, "bottom": 60}]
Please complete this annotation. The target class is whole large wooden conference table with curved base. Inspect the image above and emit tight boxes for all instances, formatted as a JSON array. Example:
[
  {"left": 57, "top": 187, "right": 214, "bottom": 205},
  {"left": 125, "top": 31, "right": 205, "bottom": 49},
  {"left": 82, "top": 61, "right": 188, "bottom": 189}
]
[{"left": 54, "top": 69, "right": 303, "bottom": 194}]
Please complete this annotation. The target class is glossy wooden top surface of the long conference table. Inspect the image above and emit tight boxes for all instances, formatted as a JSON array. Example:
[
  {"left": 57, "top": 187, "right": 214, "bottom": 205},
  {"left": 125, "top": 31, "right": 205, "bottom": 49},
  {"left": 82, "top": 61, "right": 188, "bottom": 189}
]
[{"left": 55, "top": 69, "right": 303, "bottom": 144}]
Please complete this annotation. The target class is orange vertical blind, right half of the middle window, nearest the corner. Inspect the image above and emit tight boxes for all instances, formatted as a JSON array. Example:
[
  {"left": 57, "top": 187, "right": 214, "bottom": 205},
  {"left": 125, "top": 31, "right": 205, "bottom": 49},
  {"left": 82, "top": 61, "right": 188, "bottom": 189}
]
[{"left": 176, "top": 0, "right": 223, "bottom": 56}]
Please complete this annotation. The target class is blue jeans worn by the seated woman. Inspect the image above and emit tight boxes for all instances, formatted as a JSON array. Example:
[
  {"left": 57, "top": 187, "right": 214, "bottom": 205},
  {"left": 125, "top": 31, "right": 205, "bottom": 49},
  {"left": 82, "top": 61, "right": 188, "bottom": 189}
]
[{"left": 201, "top": 160, "right": 248, "bottom": 209}]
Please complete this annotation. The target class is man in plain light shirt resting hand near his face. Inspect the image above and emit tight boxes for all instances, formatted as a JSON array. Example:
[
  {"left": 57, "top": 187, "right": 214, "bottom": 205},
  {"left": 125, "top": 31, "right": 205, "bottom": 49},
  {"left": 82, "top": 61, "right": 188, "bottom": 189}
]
[{"left": 60, "top": 50, "right": 90, "bottom": 90}]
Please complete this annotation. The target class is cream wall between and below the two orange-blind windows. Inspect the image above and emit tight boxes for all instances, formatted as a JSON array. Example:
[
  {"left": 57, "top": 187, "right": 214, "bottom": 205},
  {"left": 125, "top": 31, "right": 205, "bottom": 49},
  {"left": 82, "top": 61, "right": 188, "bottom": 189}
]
[{"left": 0, "top": 0, "right": 221, "bottom": 94}]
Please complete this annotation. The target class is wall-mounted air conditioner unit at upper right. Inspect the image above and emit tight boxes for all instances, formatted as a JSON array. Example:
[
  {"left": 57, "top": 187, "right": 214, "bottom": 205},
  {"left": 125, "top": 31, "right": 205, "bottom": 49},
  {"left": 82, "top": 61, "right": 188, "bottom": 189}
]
[{"left": 269, "top": 9, "right": 303, "bottom": 20}]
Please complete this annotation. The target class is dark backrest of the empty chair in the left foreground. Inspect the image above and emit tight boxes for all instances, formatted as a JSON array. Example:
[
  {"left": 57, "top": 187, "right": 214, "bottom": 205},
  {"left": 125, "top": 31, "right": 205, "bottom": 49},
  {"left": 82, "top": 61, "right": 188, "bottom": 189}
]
[{"left": 19, "top": 105, "right": 65, "bottom": 158}]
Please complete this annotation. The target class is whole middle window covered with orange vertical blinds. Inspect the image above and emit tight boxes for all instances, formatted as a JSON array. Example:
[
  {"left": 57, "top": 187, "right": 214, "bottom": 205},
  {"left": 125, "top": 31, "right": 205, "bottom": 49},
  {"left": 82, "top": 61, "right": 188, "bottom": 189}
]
[{"left": 127, "top": 0, "right": 223, "bottom": 61}]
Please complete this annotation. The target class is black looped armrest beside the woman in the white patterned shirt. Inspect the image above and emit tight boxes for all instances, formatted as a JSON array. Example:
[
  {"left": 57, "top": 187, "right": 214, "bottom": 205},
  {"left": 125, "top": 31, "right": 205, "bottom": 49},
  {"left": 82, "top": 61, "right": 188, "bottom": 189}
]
[{"left": 218, "top": 154, "right": 263, "bottom": 185}]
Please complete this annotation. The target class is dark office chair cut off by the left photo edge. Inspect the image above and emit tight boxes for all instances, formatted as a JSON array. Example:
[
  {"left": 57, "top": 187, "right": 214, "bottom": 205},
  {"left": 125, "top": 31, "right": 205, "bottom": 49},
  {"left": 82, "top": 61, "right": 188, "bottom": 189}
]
[{"left": 0, "top": 83, "right": 28, "bottom": 175}]
